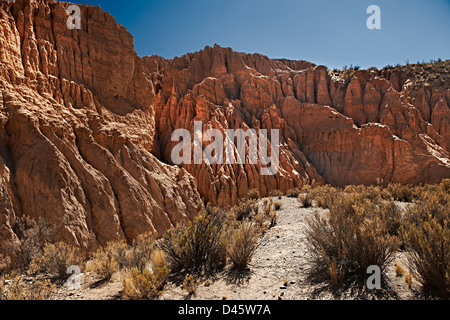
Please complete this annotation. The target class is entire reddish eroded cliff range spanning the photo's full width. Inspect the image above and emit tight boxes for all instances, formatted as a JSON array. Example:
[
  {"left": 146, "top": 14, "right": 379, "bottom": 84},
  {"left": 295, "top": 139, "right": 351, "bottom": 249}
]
[{"left": 0, "top": 0, "right": 450, "bottom": 250}]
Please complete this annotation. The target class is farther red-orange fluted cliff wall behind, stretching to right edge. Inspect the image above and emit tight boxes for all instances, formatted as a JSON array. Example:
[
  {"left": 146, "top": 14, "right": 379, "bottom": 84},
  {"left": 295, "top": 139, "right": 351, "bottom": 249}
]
[{"left": 149, "top": 46, "right": 450, "bottom": 205}]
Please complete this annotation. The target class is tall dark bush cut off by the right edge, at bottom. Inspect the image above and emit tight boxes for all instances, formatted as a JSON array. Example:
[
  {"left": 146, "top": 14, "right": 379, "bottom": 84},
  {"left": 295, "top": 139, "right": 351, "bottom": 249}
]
[{"left": 401, "top": 216, "right": 450, "bottom": 299}]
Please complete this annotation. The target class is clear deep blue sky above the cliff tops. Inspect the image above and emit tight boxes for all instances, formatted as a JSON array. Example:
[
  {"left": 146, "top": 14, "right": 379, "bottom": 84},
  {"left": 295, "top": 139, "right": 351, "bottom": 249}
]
[{"left": 67, "top": 0, "right": 450, "bottom": 68}]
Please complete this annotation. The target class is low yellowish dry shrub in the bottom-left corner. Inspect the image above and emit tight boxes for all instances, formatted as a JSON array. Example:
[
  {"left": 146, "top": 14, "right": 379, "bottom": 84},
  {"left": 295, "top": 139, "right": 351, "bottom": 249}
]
[{"left": 0, "top": 273, "right": 56, "bottom": 300}]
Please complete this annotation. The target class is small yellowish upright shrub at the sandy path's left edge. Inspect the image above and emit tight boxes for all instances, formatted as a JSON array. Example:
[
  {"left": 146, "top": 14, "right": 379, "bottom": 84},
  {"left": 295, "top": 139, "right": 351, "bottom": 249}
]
[{"left": 227, "top": 221, "right": 260, "bottom": 270}]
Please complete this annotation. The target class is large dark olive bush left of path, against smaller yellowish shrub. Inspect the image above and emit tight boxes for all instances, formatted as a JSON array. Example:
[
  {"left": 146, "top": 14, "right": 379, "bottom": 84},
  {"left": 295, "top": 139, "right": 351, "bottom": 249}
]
[{"left": 158, "top": 205, "right": 226, "bottom": 272}]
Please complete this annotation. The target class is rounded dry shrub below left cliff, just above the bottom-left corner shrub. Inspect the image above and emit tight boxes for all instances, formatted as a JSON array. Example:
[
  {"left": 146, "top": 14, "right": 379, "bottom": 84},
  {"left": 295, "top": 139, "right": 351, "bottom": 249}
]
[{"left": 29, "top": 242, "right": 83, "bottom": 279}]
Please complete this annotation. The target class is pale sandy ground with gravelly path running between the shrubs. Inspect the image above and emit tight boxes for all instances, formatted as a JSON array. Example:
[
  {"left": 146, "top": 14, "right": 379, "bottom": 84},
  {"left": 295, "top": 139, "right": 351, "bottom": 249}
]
[{"left": 55, "top": 197, "right": 418, "bottom": 300}]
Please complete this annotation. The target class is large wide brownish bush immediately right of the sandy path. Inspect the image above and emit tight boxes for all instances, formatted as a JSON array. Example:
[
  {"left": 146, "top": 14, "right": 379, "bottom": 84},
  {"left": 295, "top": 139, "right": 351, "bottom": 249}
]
[{"left": 307, "top": 193, "right": 397, "bottom": 284}]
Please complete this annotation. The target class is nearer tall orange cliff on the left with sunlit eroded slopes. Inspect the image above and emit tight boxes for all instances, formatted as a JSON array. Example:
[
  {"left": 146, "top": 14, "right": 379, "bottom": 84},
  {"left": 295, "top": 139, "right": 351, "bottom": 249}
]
[{"left": 0, "top": 1, "right": 200, "bottom": 254}]
